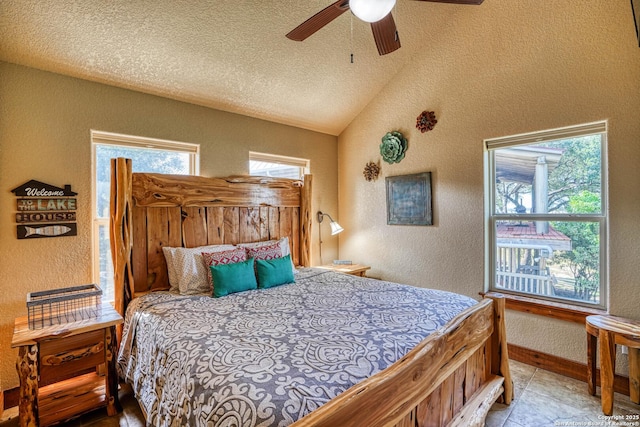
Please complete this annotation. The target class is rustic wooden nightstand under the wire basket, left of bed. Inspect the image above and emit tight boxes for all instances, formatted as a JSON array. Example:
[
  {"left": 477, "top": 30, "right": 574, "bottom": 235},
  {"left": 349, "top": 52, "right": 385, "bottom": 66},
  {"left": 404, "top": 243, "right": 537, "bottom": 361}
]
[{"left": 11, "top": 304, "right": 122, "bottom": 427}]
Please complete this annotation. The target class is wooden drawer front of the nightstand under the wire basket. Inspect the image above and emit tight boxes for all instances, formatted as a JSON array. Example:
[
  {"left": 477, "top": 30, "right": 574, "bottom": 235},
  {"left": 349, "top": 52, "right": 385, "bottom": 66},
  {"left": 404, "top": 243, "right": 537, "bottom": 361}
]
[{"left": 40, "top": 329, "right": 104, "bottom": 386}]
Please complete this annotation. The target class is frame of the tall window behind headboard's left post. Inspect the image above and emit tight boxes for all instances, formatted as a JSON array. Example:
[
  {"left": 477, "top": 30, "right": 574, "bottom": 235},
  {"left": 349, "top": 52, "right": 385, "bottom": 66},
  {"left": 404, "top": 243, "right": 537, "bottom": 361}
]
[{"left": 91, "top": 129, "right": 200, "bottom": 300}]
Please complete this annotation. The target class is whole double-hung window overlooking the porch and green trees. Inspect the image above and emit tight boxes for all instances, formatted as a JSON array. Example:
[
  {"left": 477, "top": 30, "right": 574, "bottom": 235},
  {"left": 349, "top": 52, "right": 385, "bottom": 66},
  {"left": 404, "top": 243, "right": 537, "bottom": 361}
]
[{"left": 485, "top": 121, "right": 607, "bottom": 308}]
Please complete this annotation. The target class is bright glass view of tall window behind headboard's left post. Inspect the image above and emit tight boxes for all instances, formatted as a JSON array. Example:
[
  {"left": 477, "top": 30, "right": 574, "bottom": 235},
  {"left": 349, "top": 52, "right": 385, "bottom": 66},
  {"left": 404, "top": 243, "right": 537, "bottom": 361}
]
[{"left": 94, "top": 144, "right": 194, "bottom": 301}]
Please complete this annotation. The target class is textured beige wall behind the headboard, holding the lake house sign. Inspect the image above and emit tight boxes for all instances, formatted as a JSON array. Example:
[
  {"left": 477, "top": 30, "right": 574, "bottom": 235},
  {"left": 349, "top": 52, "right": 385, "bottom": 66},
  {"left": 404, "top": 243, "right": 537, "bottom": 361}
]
[{"left": 0, "top": 62, "right": 338, "bottom": 389}]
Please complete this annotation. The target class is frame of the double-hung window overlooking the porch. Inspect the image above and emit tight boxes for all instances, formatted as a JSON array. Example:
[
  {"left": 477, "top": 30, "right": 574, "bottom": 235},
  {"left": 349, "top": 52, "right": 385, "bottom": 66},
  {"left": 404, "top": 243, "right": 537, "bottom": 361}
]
[{"left": 483, "top": 120, "right": 610, "bottom": 310}]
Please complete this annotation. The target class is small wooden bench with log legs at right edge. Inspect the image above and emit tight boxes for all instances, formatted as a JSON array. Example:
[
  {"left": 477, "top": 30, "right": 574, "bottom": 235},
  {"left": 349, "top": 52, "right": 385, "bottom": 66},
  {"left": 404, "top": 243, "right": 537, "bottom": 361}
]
[{"left": 586, "top": 315, "right": 640, "bottom": 415}]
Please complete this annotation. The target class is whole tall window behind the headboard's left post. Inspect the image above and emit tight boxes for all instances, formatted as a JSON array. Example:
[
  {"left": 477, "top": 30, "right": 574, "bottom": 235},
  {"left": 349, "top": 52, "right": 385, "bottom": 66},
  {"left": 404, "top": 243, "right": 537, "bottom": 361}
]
[{"left": 91, "top": 130, "right": 200, "bottom": 301}]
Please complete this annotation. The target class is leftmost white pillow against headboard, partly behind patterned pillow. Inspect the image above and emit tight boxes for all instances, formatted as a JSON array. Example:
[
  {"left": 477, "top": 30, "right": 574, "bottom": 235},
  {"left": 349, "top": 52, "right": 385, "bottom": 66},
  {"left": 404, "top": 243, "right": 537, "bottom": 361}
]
[{"left": 162, "top": 245, "right": 235, "bottom": 295}]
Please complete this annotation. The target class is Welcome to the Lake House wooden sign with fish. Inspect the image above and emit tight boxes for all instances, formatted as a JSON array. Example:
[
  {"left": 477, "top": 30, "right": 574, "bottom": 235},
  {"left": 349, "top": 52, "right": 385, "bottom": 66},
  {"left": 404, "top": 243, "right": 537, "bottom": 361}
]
[{"left": 11, "top": 179, "right": 78, "bottom": 239}]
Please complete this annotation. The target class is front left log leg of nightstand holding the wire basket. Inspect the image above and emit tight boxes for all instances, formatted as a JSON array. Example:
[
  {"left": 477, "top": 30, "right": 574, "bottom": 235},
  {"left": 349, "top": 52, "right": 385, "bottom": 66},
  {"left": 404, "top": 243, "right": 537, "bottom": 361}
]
[{"left": 16, "top": 344, "right": 39, "bottom": 427}]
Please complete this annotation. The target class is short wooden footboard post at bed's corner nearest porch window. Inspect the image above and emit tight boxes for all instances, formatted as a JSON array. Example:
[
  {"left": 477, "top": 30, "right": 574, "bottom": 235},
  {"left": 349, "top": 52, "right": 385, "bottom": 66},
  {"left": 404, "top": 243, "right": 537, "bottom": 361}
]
[{"left": 486, "top": 294, "right": 513, "bottom": 405}]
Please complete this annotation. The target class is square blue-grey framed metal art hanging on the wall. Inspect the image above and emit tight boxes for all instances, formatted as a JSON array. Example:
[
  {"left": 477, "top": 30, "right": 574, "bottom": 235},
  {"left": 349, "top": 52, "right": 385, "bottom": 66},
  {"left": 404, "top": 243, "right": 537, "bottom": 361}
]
[{"left": 386, "top": 172, "right": 433, "bottom": 225}]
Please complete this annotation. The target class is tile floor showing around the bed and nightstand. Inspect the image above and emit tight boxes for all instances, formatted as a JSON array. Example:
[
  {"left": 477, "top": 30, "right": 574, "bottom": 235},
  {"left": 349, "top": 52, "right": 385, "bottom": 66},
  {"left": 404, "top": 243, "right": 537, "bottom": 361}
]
[{"left": 0, "top": 361, "right": 640, "bottom": 427}]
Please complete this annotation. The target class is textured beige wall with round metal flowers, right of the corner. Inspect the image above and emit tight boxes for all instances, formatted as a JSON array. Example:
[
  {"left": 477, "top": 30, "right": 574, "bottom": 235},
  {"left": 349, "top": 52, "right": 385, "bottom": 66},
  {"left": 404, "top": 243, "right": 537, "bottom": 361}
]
[{"left": 339, "top": 0, "right": 640, "bottom": 367}]
